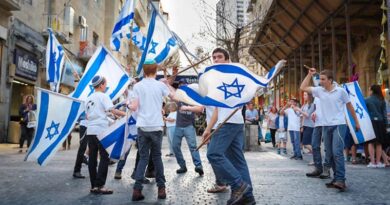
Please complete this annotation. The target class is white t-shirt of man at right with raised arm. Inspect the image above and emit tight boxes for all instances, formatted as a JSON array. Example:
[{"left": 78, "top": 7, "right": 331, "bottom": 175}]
[{"left": 312, "top": 86, "right": 350, "bottom": 126}]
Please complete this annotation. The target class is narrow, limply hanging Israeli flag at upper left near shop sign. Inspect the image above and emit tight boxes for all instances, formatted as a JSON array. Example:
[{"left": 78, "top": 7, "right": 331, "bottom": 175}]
[{"left": 46, "top": 28, "right": 65, "bottom": 92}]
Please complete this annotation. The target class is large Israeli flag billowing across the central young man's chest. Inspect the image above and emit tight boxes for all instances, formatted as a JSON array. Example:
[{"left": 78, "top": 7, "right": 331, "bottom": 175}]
[{"left": 176, "top": 60, "right": 286, "bottom": 108}]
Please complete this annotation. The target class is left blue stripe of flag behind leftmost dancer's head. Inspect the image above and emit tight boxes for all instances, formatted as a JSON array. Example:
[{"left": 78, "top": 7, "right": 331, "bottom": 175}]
[{"left": 72, "top": 48, "right": 107, "bottom": 98}]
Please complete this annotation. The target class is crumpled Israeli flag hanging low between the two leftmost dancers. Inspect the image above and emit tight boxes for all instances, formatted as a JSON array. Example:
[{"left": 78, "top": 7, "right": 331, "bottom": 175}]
[{"left": 98, "top": 115, "right": 137, "bottom": 160}]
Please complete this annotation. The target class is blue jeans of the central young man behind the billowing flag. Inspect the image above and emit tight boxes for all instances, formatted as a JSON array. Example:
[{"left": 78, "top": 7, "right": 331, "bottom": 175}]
[{"left": 207, "top": 123, "right": 253, "bottom": 196}]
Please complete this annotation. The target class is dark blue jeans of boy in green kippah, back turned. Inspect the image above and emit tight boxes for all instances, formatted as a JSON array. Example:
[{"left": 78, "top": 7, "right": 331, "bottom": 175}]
[{"left": 133, "top": 128, "right": 165, "bottom": 190}]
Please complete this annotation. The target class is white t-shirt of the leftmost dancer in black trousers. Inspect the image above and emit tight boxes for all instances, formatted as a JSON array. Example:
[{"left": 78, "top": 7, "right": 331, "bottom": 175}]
[{"left": 85, "top": 92, "right": 114, "bottom": 135}]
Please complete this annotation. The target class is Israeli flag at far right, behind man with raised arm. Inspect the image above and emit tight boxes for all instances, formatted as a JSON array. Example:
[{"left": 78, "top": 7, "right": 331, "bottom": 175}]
[{"left": 343, "top": 81, "right": 375, "bottom": 144}]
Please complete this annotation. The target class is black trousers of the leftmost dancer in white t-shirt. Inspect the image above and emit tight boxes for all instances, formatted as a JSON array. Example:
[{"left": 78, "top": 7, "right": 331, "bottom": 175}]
[{"left": 86, "top": 135, "right": 110, "bottom": 188}]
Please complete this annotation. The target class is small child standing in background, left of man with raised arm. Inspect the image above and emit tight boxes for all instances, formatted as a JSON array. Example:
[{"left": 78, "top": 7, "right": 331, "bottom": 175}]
[{"left": 275, "top": 110, "right": 288, "bottom": 154}]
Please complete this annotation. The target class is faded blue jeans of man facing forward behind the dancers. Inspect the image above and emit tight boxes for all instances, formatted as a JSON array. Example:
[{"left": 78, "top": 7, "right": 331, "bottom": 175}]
[{"left": 172, "top": 125, "right": 202, "bottom": 167}]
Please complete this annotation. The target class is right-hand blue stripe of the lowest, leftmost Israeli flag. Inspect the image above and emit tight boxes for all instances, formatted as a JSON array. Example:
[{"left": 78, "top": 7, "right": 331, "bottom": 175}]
[{"left": 38, "top": 102, "right": 81, "bottom": 165}]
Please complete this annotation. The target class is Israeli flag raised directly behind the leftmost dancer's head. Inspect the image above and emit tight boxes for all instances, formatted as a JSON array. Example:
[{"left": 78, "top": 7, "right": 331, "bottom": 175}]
[{"left": 72, "top": 46, "right": 130, "bottom": 101}]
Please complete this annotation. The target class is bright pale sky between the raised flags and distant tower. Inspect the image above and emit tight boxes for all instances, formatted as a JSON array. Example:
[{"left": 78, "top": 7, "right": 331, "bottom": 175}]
[{"left": 161, "top": 0, "right": 217, "bottom": 67}]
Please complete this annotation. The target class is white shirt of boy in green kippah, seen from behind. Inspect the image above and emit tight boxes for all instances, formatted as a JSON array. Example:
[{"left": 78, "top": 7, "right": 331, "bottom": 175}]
[{"left": 133, "top": 78, "right": 169, "bottom": 127}]
